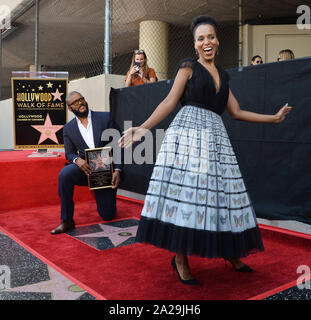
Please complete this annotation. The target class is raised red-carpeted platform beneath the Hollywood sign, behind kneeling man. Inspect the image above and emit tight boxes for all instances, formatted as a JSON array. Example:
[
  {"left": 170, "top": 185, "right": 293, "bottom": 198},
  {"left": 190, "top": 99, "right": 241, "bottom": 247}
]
[{"left": 0, "top": 151, "right": 92, "bottom": 213}]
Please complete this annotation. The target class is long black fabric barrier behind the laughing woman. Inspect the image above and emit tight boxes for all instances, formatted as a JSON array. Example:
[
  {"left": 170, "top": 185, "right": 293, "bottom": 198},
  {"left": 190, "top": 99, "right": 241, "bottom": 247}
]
[{"left": 110, "top": 57, "right": 311, "bottom": 224}]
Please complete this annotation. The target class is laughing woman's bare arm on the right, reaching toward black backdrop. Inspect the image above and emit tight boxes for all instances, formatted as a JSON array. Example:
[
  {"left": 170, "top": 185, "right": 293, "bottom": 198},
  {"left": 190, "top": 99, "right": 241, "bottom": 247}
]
[{"left": 227, "top": 90, "right": 292, "bottom": 123}]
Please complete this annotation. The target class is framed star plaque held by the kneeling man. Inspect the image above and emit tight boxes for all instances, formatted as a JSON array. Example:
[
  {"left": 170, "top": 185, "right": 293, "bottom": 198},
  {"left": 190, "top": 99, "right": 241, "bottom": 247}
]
[{"left": 85, "top": 147, "right": 113, "bottom": 190}]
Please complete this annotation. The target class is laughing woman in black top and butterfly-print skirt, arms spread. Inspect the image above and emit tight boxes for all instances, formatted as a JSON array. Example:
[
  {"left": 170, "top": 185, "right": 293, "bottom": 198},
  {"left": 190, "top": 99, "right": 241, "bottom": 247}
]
[{"left": 119, "top": 16, "right": 291, "bottom": 285}]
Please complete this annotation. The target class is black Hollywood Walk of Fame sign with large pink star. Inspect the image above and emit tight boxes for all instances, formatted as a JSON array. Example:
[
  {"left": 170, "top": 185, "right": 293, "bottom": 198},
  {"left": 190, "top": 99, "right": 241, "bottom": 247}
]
[{"left": 12, "top": 77, "right": 68, "bottom": 149}]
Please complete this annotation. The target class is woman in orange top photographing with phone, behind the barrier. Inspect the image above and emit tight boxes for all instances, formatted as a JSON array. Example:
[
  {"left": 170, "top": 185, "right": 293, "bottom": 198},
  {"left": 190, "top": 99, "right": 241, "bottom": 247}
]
[{"left": 125, "top": 50, "right": 157, "bottom": 87}]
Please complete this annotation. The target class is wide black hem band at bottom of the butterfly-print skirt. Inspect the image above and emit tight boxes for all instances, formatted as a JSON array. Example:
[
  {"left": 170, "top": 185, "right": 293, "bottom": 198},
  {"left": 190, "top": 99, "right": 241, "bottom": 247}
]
[{"left": 136, "top": 216, "right": 264, "bottom": 258}]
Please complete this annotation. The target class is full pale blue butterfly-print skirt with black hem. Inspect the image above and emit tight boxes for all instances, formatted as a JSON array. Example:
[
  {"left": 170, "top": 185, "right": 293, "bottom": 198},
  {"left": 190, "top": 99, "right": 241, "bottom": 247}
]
[{"left": 136, "top": 106, "right": 264, "bottom": 258}]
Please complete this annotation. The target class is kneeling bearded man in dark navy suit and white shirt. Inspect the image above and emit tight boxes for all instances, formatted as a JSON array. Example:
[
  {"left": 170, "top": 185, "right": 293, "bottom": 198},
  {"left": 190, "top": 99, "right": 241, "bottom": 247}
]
[{"left": 51, "top": 91, "right": 122, "bottom": 234}]
